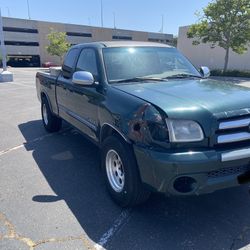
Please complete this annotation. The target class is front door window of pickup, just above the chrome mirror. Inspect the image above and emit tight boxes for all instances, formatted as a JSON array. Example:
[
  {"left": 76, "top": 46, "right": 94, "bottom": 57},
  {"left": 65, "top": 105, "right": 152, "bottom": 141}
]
[{"left": 76, "top": 49, "right": 98, "bottom": 79}]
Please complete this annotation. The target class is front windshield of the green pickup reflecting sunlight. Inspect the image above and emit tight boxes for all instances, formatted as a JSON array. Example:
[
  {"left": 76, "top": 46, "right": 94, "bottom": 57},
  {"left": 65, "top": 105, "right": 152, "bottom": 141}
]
[{"left": 103, "top": 47, "right": 201, "bottom": 83}]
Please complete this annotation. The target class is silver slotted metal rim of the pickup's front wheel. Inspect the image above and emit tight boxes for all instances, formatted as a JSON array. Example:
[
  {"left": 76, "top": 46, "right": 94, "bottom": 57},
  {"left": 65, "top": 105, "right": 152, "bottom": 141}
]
[{"left": 106, "top": 149, "right": 125, "bottom": 192}]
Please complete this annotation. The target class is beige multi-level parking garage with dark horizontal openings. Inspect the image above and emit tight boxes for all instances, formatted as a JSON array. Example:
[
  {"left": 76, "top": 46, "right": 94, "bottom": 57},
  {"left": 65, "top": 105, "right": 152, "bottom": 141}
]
[{"left": 3, "top": 17, "right": 173, "bottom": 66}]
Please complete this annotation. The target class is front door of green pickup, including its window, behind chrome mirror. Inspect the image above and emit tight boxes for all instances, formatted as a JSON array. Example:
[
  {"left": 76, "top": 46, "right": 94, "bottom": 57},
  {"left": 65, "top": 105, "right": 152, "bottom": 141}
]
[{"left": 56, "top": 48, "right": 103, "bottom": 141}]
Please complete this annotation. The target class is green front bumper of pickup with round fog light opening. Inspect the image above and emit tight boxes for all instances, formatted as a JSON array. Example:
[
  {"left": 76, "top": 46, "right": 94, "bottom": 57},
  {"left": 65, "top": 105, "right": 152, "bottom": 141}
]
[{"left": 134, "top": 145, "right": 250, "bottom": 195}]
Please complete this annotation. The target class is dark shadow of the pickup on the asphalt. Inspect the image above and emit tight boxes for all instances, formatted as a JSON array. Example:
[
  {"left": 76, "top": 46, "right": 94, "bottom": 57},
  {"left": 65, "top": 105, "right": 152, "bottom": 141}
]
[{"left": 19, "top": 120, "right": 250, "bottom": 249}]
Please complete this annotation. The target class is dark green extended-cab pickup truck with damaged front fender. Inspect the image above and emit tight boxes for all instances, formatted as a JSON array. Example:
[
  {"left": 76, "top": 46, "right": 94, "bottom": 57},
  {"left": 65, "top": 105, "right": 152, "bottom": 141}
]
[{"left": 36, "top": 41, "right": 250, "bottom": 207}]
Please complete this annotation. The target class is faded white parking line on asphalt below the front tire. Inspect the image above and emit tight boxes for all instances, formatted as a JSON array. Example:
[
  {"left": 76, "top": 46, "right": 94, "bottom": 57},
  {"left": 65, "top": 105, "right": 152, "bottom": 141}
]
[{"left": 94, "top": 210, "right": 131, "bottom": 250}]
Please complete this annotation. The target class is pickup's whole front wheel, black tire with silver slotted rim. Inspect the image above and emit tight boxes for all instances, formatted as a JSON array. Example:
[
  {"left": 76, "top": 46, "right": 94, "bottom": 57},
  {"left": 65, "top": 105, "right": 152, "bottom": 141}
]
[{"left": 102, "top": 136, "right": 150, "bottom": 207}]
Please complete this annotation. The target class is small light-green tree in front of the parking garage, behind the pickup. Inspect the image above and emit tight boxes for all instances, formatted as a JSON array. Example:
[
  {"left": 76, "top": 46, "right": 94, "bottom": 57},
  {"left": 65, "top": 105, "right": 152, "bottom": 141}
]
[{"left": 46, "top": 29, "right": 70, "bottom": 63}]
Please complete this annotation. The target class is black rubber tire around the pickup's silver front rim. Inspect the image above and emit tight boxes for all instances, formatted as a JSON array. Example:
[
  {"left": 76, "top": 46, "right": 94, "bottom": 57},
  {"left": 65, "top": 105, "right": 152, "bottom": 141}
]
[{"left": 101, "top": 136, "right": 150, "bottom": 207}]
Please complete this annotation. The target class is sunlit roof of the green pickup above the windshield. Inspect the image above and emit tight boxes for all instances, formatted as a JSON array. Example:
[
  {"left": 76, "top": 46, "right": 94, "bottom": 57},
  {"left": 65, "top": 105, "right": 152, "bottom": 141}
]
[{"left": 74, "top": 41, "right": 172, "bottom": 48}]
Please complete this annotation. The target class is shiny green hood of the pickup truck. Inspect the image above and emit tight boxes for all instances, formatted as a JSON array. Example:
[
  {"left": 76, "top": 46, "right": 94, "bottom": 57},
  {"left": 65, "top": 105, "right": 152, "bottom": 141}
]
[{"left": 113, "top": 79, "right": 250, "bottom": 121}]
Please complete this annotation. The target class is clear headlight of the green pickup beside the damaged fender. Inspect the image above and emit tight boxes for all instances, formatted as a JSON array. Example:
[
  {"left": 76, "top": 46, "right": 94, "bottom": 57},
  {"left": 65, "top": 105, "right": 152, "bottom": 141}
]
[{"left": 166, "top": 119, "right": 204, "bottom": 142}]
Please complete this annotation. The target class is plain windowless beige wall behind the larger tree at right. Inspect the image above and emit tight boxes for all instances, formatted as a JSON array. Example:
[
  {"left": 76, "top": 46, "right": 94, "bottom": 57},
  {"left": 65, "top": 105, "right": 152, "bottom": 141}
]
[{"left": 177, "top": 26, "right": 250, "bottom": 71}]
